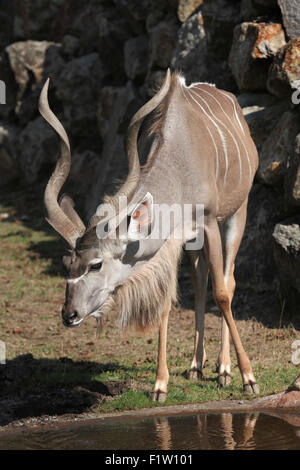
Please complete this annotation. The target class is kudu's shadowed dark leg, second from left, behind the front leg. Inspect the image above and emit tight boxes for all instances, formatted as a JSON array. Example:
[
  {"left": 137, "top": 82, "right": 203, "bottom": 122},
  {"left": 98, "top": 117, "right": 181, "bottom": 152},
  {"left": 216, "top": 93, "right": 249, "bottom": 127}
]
[{"left": 189, "top": 250, "right": 208, "bottom": 379}]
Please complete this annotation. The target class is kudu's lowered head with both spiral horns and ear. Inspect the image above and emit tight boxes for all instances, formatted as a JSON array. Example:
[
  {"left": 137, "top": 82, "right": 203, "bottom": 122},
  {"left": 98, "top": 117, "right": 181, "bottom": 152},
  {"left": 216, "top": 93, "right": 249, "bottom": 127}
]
[{"left": 39, "top": 70, "right": 171, "bottom": 327}]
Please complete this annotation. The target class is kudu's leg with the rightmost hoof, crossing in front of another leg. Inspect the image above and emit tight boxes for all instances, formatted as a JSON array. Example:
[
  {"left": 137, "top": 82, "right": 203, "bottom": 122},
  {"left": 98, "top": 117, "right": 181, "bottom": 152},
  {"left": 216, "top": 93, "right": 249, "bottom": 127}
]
[{"left": 205, "top": 209, "right": 259, "bottom": 393}]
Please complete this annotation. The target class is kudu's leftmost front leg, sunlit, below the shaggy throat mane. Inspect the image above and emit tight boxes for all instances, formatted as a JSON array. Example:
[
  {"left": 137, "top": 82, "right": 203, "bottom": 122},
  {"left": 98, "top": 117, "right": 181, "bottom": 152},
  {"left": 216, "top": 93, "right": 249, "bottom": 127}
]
[{"left": 152, "top": 300, "right": 171, "bottom": 402}]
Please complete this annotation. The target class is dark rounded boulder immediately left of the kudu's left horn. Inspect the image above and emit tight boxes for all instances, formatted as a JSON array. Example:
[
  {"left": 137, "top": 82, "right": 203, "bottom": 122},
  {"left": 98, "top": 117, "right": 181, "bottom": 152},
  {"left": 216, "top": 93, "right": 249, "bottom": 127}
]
[{"left": 18, "top": 116, "right": 59, "bottom": 184}]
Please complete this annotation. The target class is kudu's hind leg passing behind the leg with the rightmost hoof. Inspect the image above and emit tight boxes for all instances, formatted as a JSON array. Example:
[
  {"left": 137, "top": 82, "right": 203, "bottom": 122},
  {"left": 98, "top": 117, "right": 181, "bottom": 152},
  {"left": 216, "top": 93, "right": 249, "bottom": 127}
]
[{"left": 217, "top": 200, "right": 247, "bottom": 387}]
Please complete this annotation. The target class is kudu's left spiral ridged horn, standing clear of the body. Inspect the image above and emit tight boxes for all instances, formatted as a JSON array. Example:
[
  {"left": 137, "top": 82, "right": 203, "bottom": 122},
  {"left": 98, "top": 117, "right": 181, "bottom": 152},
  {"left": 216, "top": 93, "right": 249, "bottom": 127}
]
[{"left": 39, "top": 78, "right": 81, "bottom": 248}]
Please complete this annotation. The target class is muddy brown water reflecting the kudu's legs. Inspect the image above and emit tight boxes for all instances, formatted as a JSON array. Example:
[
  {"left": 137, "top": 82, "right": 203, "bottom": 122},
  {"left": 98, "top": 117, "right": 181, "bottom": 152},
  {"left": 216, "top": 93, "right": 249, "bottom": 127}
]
[{"left": 0, "top": 412, "right": 300, "bottom": 450}]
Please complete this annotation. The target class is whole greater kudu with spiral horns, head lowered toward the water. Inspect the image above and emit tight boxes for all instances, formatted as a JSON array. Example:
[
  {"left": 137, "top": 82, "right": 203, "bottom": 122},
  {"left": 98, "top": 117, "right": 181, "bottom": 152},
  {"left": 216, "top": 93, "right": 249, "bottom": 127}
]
[{"left": 40, "top": 70, "right": 258, "bottom": 401}]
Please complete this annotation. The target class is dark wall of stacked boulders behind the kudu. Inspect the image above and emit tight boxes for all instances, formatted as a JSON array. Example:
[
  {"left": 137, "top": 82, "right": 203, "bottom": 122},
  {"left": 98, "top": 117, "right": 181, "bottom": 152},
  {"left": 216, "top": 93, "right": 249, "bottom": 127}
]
[{"left": 0, "top": 0, "right": 300, "bottom": 315}]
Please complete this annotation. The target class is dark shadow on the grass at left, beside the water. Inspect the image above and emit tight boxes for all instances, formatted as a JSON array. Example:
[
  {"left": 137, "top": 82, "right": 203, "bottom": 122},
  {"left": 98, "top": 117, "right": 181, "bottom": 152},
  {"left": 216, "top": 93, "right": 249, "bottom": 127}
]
[{"left": 0, "top": 354, "right": 134, "bottom": 426}]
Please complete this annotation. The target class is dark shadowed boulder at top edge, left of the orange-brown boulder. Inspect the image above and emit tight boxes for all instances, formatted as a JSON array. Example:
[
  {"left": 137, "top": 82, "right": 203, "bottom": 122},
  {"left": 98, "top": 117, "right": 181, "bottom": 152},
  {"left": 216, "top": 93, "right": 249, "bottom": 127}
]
[{"left": 201, "top": 0, "right": 240, "bottom": 60}]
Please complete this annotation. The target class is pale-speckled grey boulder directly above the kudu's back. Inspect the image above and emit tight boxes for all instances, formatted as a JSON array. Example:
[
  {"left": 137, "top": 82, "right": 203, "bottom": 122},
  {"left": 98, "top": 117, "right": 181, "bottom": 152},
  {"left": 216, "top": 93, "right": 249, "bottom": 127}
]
[{"left": 171, "top": 12, "right": 208, "bottom": 83}]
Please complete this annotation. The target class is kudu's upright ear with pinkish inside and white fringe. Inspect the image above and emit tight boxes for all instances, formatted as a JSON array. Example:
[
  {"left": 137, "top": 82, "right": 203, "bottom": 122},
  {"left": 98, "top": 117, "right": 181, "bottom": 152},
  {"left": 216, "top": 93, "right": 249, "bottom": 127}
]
[{"left": 127, "top": 193, "right": 153, "bottom": 241}]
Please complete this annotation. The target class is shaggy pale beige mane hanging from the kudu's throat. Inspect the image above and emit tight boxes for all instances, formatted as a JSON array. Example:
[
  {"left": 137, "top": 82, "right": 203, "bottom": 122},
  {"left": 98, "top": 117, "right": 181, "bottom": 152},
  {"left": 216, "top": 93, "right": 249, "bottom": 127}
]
[{"left": 113, "top": 239, "right": 182, "bottom": 331}]
